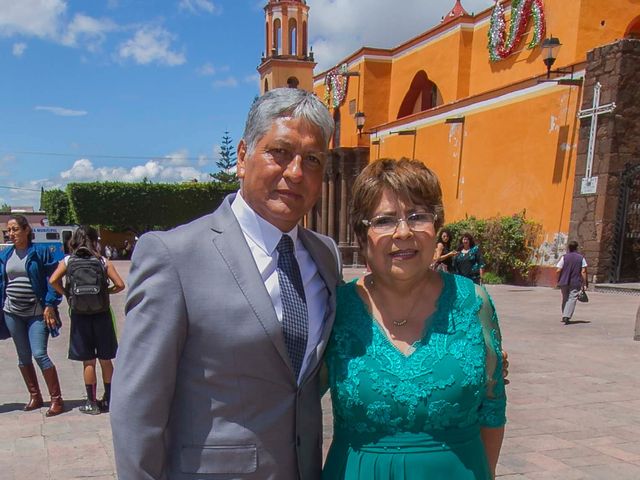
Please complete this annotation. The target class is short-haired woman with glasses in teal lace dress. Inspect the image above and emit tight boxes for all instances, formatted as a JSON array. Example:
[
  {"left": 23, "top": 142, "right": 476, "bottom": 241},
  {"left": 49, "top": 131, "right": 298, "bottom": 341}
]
[{"left": 323, "top": 159, "right": 506, "bottom": 480}]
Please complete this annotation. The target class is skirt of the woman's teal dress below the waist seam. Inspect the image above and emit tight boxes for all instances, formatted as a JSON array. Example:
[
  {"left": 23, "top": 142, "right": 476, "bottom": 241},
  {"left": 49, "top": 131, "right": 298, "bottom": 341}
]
[{"left": 322, "top": 427, "right": 491, "bottom": 480}]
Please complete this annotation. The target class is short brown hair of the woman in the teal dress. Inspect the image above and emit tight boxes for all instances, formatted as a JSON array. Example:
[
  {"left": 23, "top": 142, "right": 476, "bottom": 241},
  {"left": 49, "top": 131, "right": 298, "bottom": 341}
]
[{"left": 351, "top": 158, "right": 444, "bottom": 248}]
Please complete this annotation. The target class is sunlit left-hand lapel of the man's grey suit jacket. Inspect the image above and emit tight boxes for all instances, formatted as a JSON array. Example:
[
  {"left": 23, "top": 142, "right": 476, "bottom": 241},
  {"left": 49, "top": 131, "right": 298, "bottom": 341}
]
[{"left": 212, "top": 195, "right": 293, "bottom": 371}]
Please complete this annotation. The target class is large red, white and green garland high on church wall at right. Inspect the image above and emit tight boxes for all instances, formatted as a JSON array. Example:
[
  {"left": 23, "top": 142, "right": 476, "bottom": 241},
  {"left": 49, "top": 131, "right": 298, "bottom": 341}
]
[{"left": 488, "top": 0, "right": 545, "bottom": 62}]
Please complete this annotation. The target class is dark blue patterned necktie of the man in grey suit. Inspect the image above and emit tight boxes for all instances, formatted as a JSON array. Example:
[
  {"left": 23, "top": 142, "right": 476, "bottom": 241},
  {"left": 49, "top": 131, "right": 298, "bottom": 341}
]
[{"left": 276, "top": 235, "right": 309, "bottom": 379}]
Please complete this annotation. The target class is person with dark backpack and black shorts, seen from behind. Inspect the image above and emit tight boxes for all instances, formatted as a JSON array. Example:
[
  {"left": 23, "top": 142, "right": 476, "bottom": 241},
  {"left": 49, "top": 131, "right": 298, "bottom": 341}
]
[{"left": 49, "top": 226, "right": 124, "bottom": 415}]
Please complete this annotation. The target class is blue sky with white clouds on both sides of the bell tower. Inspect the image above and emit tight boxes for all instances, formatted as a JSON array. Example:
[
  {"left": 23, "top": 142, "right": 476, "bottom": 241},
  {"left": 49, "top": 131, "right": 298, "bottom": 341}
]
[{"left": 0, "top": 0, "right": 493, "bottom": 208}]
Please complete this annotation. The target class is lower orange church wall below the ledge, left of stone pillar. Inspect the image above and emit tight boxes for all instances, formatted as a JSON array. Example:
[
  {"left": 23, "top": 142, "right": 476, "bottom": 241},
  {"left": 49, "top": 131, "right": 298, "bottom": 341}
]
[{"left": 371, "top": 87, "right": 579, "bottom": 237}]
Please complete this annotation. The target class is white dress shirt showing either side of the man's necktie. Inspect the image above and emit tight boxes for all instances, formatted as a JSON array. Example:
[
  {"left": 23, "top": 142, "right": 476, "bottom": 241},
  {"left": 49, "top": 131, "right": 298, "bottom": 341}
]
[{"left": 231, "top": 192, "right": 329, "bottom": 383}]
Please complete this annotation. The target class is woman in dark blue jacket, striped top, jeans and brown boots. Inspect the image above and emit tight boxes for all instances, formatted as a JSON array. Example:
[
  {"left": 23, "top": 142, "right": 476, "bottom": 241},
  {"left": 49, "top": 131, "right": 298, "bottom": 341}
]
[{"left": 0, "top": 215, "right": 64, "bottom": 417}]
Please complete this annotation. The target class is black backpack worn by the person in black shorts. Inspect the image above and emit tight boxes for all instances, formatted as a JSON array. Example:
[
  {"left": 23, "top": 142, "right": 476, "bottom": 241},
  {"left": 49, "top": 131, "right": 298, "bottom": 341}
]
[{"left": 66, "top": 248, "right": 109, "bottom": 315}]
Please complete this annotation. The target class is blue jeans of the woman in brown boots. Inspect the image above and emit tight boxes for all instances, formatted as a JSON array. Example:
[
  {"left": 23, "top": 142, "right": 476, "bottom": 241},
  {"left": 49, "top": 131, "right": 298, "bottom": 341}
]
[{"left": 4, "top": 312, "right": 53, "bottom": 370}]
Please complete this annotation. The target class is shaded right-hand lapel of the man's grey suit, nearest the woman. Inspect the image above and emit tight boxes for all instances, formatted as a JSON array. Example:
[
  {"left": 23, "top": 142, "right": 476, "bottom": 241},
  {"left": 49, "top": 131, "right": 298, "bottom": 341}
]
[{"left": 298, "top": 228, "right": 338, "bottom": 383}]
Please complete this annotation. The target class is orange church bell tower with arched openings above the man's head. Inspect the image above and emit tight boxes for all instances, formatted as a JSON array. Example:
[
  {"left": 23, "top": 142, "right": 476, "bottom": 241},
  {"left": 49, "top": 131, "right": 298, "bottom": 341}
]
[{"left": 258, "top": 0, "right": 316, "bottom": 95}]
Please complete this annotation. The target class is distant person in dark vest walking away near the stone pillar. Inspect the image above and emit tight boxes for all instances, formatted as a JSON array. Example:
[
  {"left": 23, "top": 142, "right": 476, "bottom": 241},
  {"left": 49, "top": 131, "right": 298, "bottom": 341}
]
[{"left": 556, "top": 240, "right": 589, "bottom": 325}]
